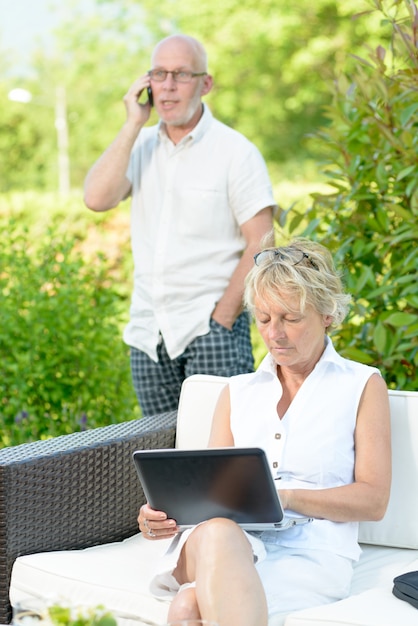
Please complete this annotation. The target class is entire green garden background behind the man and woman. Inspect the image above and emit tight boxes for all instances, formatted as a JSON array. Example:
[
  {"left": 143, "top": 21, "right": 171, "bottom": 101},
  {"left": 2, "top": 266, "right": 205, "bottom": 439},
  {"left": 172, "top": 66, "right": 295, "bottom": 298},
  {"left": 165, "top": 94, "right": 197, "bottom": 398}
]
[{"left": 0, "top": 0, "right": 418, "bottom": 446}]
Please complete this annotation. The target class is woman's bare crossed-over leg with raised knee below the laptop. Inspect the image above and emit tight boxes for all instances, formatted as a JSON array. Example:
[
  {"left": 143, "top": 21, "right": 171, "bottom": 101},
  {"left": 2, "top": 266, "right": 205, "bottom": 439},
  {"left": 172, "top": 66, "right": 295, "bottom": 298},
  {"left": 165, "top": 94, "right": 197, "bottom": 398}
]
[{"left": 173, "top": 518, "right": 268, "bottom": 626}]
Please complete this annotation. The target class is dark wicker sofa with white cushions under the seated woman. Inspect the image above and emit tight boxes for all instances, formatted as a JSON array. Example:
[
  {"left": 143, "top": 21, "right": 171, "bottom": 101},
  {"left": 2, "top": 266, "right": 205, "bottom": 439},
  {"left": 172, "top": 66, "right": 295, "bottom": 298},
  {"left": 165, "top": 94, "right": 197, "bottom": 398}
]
[{"left": 0, "top": 376, "right": 418, "bottom": 626}]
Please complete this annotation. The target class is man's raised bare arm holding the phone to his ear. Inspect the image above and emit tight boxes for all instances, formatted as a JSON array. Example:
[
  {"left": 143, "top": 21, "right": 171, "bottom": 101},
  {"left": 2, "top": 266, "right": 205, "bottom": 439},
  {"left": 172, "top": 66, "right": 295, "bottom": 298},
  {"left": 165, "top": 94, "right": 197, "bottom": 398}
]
[{"left": 84, "top": 74, "right": 150, "bottom": 211}]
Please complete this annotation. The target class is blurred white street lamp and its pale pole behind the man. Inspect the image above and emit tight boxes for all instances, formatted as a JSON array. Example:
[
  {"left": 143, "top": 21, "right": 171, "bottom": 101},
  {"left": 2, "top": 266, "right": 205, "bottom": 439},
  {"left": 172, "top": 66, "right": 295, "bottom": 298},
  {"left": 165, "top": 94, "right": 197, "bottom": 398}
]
[{"left": 8, "top": 87, "right": 70, "bottom": 196}]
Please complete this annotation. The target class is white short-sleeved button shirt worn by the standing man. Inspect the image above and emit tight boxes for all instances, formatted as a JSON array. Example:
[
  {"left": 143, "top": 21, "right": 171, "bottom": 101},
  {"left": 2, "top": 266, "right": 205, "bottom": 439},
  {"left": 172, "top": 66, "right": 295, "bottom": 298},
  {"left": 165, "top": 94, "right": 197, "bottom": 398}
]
[{"left": 124, "top": 106, "right": 275, "bottom": 361}]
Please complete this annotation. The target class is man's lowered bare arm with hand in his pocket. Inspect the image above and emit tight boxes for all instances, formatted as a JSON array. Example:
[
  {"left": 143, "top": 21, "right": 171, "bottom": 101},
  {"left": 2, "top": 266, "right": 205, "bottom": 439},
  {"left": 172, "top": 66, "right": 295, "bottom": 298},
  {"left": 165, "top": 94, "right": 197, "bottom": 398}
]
[{"left": 212, "top": 207, "right": 274, "bottom": 329}]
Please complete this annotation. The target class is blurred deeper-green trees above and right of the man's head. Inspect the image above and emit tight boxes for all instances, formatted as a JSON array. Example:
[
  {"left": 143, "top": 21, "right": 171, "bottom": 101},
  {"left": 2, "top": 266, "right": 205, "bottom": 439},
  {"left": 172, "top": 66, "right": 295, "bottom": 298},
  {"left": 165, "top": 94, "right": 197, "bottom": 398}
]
[{"left": 124, "top": 0, "right": 386, "bottom": 162}]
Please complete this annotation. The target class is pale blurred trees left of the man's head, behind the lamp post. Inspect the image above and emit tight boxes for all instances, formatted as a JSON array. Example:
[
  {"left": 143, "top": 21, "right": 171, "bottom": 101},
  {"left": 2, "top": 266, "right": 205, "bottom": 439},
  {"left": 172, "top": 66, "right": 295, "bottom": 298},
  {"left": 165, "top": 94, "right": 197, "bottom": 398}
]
[{"left": 0, "top": 0, "right": 150, "bottom": 193}]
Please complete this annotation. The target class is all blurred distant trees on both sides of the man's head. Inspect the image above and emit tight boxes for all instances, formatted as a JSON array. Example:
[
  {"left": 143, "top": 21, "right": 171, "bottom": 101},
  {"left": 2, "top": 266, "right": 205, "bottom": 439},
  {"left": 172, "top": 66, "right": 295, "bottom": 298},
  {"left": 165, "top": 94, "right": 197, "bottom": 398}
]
[{"left": 0, "top": 0, "right": 392, "bottom": 192}]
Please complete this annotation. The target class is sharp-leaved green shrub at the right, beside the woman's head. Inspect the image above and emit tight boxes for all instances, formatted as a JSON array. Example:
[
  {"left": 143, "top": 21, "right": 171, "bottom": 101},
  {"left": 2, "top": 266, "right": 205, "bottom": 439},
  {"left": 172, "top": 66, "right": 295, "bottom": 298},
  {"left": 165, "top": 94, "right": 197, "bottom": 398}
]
[{"left": 303, "top": 0, "right": 418, "bottom": 389}]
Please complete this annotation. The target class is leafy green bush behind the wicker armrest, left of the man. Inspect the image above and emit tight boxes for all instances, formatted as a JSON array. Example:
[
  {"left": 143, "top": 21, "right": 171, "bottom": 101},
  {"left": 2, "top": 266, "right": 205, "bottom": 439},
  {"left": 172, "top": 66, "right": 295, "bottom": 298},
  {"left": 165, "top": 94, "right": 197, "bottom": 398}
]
[{"left": 0, "top": 218, "right": 139, "bottom": 446}]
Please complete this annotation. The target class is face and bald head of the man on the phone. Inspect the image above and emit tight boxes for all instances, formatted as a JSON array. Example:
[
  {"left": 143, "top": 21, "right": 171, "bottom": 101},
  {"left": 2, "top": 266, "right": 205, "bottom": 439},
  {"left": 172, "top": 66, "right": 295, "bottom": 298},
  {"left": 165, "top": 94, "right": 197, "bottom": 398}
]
[{"left": 151, "top": 38, "right": 212, "bottom": 132}]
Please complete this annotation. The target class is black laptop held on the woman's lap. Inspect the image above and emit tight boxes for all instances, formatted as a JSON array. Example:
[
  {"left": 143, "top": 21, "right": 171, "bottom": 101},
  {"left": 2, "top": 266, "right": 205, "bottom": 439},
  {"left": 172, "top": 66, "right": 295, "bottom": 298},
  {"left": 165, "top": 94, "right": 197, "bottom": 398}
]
[{"left": 133, "top": 448, "right": 311, "bottom": 530}]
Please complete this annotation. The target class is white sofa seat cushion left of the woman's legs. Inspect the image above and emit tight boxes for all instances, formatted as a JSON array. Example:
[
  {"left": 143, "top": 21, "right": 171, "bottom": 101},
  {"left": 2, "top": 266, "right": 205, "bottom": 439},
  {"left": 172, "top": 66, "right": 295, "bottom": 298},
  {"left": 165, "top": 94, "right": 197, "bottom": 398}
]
[{"left": 10, "top": 534, "right": 171, "bottom": 626}]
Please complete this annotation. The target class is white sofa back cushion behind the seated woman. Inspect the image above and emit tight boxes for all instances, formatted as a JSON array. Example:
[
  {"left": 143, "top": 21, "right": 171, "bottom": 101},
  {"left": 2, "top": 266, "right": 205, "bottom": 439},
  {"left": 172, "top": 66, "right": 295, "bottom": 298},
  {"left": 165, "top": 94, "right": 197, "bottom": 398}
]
[{"left": 176, "top": 374, "right": 418, "bottom": 549}]
